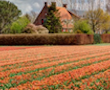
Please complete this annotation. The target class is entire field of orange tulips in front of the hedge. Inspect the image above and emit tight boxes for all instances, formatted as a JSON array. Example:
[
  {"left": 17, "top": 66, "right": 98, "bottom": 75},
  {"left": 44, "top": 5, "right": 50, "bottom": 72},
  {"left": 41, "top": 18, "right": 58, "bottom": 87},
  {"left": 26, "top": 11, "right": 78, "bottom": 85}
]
[{"left": 0, "top": 45, "right": 110, "bottom": 90}]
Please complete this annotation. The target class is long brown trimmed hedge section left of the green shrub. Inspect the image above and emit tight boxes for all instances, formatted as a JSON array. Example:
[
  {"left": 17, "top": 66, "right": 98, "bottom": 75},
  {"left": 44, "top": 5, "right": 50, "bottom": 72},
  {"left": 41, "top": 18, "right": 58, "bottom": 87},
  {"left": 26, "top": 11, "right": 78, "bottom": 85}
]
[{"left": 0, "top": 34, "right": 94, "bottom": 45}]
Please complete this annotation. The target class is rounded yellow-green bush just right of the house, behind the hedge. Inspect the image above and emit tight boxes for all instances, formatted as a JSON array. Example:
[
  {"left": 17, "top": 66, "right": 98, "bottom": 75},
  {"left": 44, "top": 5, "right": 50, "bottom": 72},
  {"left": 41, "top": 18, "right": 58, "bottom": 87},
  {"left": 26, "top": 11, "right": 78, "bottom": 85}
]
[{"left": 74, "top": 20, "right": 93, "bottom": 34}]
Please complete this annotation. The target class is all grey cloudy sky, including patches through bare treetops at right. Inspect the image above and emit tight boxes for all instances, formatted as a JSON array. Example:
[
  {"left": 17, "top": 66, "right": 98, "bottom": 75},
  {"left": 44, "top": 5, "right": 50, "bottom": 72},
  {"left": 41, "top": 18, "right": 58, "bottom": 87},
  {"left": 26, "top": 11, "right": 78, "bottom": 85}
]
[{"left": 7, "top": 0, "right": 106, "bottom": 14}]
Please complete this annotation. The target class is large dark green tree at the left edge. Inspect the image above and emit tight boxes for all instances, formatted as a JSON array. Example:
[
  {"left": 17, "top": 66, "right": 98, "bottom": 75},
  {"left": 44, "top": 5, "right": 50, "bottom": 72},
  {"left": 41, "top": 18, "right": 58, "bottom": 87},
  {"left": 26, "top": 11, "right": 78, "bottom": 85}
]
[{"left": 0, "top": 1, "right": 21, "bottom": 33}]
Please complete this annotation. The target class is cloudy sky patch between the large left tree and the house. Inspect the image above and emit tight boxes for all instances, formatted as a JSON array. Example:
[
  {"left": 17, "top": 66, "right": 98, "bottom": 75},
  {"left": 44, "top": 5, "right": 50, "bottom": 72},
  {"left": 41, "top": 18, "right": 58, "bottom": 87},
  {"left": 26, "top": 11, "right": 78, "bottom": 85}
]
[{"left": 8, "top": 0, "right": 45, "bottom": 14}]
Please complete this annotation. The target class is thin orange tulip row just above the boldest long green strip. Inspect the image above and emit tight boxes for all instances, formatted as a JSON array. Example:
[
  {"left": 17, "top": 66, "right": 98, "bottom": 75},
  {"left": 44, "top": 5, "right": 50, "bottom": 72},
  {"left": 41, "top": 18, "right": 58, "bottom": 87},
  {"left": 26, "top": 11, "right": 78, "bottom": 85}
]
[{"left": 0, "top": 50, "right": 110, "bottom": 78}]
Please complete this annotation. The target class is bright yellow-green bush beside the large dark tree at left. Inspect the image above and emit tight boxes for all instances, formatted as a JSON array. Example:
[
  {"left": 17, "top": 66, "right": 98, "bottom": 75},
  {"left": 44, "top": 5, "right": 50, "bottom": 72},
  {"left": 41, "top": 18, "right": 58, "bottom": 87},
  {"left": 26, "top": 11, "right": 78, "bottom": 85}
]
[{"left": 10, "top": 16, "right": 30, "bottom": 33}]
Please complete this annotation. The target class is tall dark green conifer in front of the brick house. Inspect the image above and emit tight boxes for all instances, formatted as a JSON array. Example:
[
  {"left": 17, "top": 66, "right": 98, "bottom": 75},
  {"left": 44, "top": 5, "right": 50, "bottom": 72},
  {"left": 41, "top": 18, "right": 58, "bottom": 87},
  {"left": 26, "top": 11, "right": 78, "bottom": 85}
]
[{"left": 44, "top": 4, "right": 62, "bottom": 33}]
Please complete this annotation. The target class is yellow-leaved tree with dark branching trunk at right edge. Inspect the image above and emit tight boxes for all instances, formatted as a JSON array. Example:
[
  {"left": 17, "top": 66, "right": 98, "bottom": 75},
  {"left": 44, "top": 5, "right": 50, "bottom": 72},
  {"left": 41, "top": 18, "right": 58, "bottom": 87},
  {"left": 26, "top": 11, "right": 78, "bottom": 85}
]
[{"left": 86, "top": 8, "right": 110, "bottom": 32}]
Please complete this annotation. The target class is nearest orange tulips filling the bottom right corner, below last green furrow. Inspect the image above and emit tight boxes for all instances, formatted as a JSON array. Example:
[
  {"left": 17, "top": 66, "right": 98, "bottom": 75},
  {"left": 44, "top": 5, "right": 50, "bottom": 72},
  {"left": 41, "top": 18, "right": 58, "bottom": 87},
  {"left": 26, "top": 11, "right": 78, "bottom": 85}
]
[{"left": 71, "top": 69, "right": 110, "bottom": 90}]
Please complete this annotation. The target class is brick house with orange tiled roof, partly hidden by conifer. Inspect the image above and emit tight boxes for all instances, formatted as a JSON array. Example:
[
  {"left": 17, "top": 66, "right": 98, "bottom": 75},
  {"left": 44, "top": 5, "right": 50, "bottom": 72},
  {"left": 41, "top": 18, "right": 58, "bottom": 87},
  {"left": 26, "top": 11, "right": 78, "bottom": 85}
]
[{"left": 34, "top": 2, "right": 80, "bottom": 32}]
